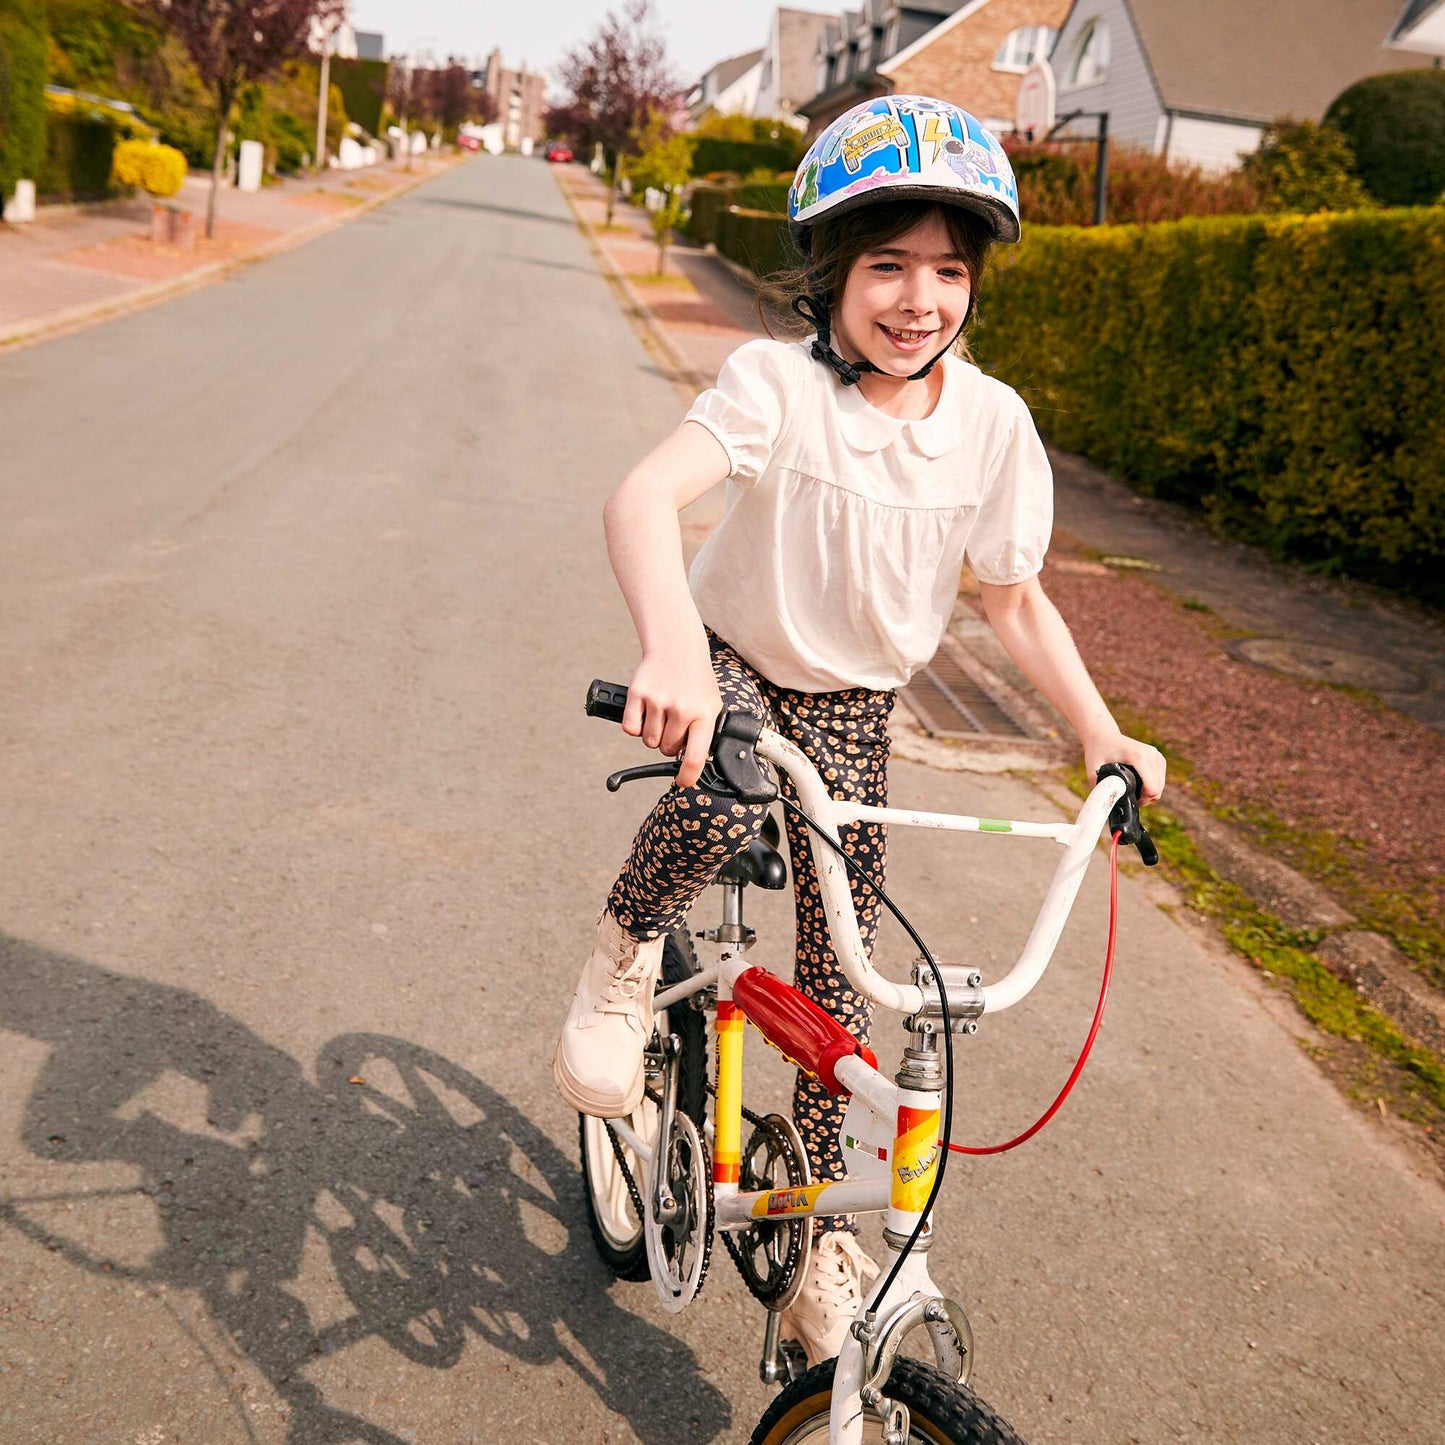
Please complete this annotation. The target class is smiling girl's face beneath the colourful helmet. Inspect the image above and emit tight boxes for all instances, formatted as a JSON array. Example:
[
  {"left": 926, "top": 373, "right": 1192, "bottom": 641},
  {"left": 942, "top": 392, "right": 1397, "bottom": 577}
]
[{"left": 834, "top": 212, "right": 971, "bottom": 379}]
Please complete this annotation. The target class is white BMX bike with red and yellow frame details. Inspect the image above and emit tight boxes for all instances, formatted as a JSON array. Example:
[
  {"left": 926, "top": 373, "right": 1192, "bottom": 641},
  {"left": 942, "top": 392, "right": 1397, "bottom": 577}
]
[{"left": 581, "top": 682, "right": 1157, "bottom": 1445}]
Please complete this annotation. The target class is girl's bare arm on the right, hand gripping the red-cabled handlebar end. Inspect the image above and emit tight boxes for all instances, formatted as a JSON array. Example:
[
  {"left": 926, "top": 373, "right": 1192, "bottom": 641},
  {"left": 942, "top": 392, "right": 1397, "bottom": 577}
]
[{"left": 978, "top": 577, "right": 1165, "bottom": 803}]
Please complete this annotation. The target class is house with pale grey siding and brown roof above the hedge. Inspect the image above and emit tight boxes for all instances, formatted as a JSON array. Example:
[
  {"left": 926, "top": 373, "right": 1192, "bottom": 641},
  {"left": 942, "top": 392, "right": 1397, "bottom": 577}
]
[{"left": 1049, "top": 0, "right": 1420, "bottom": 169}]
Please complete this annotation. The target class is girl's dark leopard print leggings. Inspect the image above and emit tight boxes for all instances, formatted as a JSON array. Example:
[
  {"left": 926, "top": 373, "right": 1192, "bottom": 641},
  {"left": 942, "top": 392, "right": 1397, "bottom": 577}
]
[{"left": 607, "top": 634, "right": 893, "bottom": 1233}]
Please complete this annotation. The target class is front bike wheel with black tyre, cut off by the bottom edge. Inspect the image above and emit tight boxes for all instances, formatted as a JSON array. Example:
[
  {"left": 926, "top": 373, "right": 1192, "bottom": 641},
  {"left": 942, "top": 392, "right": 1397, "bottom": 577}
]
[{"left": 750, "top": 1357, "right": 1023, "bottom": 1445}]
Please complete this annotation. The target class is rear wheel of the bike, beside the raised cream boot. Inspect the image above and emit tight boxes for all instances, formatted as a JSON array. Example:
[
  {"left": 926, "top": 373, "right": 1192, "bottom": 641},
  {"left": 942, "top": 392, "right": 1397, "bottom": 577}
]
[{"left": 578, "top": 928, "right": 708, "bottom": 1280}]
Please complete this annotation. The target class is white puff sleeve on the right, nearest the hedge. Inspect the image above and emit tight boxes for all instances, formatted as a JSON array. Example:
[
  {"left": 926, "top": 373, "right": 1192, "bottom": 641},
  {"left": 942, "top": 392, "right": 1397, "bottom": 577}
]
[{"left": 967, "top": 393, "right": 1053, "bottom": 585}]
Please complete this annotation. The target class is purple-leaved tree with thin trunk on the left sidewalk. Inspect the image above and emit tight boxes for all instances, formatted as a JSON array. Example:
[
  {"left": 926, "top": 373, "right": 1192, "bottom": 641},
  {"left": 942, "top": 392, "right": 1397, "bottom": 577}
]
[{"left": 133, "top": 0, "right": 345, "bottom": 237}]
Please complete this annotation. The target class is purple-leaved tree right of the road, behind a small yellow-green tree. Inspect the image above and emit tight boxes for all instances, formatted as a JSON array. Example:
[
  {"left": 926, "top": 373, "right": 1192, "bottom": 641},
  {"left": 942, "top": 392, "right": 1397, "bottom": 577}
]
[{"left": 548, "top": 0, "right": 682, "bottom": 225}]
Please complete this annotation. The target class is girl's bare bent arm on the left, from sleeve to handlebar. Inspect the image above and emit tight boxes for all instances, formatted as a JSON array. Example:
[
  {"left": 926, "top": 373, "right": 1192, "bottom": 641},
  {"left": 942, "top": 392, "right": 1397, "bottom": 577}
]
[{"left": 603, "top": 422, "right": 730, "bottom": 788}]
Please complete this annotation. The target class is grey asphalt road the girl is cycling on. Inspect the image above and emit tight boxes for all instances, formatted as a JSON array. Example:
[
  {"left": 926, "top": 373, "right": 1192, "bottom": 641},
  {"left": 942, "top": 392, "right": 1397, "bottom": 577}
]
[{"left": 0, "top": 160, "right": 1445, "bottom": 1445}]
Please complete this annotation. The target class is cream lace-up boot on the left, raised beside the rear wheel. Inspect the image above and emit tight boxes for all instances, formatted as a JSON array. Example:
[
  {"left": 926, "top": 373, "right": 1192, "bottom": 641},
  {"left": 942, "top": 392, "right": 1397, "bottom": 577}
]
[{"left": 552, "top": 913, "right": 663, "bottom": 1118}]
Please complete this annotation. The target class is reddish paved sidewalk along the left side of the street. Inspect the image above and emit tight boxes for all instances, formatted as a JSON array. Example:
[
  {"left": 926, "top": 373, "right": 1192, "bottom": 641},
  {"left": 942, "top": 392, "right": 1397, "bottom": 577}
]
[{"left": 0, "top": 156, "right": 457, "bottom": 347}]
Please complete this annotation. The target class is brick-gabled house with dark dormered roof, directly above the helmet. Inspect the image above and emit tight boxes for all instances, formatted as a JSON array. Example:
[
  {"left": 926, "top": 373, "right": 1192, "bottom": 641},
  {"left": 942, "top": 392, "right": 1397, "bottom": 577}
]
[{"left": 803, "top": 0, "right": 1069, "bottom": 134}]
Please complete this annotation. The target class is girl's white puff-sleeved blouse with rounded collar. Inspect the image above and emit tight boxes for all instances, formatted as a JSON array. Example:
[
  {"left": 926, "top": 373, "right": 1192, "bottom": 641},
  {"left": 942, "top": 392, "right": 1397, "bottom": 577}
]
[{"left": 686, "top": 341, "right": 1053, "bottom": 692}]
